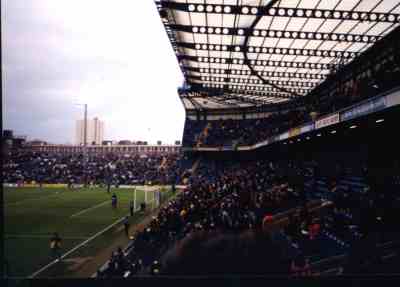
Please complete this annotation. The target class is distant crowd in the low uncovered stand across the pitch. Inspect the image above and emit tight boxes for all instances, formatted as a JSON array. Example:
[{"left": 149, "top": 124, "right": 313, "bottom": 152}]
[{"left": 2, "top": 149, "right": 180, "bottom": 185}]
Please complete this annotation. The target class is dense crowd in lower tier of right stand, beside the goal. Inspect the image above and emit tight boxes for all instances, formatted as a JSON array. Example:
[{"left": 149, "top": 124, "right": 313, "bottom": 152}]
[{"left": 99, "top": 161, "right": 310, "bottom": 276}]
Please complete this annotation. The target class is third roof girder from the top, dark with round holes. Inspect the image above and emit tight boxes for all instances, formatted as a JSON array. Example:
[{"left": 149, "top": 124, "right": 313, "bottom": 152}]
[{"left": 177, "top": 42, "right": 360, "bottom": 59}]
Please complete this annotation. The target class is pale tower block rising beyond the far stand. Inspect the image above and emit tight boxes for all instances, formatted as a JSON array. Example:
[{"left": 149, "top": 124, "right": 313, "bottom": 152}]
[{"left": 76, "top": 118, "right": 104, "bottom": 145}]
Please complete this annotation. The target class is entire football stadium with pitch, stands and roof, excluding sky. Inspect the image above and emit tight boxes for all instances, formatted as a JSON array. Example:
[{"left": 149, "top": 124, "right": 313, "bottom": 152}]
[{"left": 2, "top": 0, "right": 400, "bottom": 279}]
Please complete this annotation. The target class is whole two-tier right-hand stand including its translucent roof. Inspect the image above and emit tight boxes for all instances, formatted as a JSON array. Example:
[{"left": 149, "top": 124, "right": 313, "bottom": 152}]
[{"left": 90, "top": 1, "right": 400, "bottom": 277}]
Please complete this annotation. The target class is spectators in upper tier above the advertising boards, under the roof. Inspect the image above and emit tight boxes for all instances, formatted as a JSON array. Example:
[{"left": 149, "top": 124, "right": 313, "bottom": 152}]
[{"left": 183, "top": 61, "right": 400, "bottom": 150}]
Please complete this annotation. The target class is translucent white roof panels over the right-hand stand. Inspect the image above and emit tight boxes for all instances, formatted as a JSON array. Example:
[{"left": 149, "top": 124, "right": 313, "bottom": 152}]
[{"left": 155, "top": 0, "right": 400, "bottom": 111}]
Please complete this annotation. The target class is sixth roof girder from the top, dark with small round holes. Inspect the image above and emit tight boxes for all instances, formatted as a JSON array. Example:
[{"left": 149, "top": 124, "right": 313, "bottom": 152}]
[{"left": 187, "top": 75, "right": 318, "bottom": 88}]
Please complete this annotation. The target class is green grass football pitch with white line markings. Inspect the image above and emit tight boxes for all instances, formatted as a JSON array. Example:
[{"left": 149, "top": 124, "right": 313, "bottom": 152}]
[{"left": 3, "top": 187, "right": 171, "bottom": 277}]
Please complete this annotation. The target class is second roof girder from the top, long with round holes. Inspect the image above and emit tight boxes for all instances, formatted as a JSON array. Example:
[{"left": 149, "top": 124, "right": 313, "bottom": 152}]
[{"left": 168, "top": 24, "right": 382, "bottom": 43}]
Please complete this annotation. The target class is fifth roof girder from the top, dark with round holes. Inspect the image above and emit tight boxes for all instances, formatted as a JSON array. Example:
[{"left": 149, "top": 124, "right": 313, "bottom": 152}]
[{"left": 182, "top": 66, "right": 327, "bottom": 80}]
